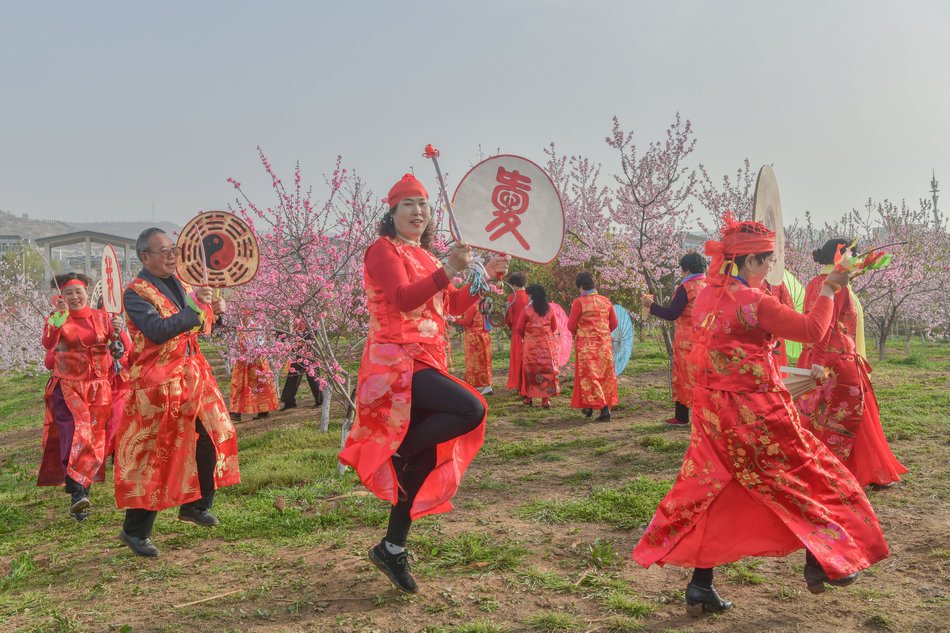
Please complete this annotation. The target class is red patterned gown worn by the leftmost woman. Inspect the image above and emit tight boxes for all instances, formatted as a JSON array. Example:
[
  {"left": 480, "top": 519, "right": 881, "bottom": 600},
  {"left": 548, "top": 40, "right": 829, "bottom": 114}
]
[{"left": 37, "top": 306, "right": 121, "bottom": 487}]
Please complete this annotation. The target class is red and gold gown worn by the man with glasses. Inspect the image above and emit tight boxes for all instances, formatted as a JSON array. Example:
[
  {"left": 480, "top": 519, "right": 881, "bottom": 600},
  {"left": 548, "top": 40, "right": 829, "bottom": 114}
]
[{"left": 115, "top": 277, "right": 241, "bottom": 510}]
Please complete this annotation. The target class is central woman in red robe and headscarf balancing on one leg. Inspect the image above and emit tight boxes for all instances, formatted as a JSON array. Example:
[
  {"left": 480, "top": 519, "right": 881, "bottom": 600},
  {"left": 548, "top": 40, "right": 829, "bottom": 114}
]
[{"left": 340, "top": 174, "right": 509, "bottom": 593}]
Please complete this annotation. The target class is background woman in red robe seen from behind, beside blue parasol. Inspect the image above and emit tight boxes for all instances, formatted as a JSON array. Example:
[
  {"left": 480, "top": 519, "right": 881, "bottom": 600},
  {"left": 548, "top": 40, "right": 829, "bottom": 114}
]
[{"left": 567, "top": 273, "right": 619, "bottom": 422}]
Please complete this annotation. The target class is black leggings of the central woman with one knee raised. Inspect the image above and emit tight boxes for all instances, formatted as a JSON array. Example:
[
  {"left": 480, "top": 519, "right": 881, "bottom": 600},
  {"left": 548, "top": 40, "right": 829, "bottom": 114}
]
[{"left": 386, "top": 369, "right": 485, "bottom": 547}]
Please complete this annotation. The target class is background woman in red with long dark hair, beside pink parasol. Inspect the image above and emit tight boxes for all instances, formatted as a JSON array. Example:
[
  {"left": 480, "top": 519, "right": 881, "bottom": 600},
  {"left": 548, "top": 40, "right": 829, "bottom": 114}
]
[{"left": 515, "top": 284, "right": 561, "bottom": 409}]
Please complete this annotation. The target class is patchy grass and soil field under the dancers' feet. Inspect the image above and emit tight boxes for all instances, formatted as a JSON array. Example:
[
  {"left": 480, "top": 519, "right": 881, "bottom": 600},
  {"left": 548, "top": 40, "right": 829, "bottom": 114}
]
[{"left": 0, "top": 340, "right": 950, "bottom": 633}]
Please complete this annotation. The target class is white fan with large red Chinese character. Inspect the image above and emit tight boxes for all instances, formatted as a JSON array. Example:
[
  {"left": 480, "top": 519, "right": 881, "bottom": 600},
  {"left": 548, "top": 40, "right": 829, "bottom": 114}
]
[{"left": 450, "top": 155, "right": 564, "bottom": 264}]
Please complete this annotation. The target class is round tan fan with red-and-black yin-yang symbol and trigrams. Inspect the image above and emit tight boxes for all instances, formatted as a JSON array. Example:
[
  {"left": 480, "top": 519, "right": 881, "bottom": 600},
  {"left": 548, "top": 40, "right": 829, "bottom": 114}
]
[{"left": 178, "top": 211, "right": 260, "bottom": 288}]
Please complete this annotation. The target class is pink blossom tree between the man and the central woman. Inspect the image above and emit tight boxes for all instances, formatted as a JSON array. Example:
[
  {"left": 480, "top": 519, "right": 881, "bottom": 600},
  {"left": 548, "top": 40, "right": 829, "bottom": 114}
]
[{"left": 226, "top": 148, "right": 384, "bottom": 450}]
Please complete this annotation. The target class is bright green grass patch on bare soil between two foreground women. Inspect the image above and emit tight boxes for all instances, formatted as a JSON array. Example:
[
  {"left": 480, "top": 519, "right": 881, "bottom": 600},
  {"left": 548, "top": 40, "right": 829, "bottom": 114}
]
[{"left": 518, "top": 477, "right": 672, "bottom": 530}]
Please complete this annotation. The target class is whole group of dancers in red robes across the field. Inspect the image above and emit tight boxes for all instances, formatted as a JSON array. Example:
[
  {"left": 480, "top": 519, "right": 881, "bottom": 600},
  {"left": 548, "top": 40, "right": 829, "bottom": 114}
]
[{"left": 38, "top": 174, "right": 906, "bottom": 615}]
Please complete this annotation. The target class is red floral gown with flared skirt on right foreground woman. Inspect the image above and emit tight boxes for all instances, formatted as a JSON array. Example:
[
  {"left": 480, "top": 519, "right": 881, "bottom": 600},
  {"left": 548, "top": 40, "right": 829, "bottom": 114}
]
[{"left": 633, "top": 278, "right": 888, "bottom": 579}]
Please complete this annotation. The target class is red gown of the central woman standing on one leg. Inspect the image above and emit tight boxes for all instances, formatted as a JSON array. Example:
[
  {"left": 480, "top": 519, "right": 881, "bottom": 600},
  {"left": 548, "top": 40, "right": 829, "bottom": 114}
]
[{"left": 340, "top": 237, "right": 487, "bottom": 521}]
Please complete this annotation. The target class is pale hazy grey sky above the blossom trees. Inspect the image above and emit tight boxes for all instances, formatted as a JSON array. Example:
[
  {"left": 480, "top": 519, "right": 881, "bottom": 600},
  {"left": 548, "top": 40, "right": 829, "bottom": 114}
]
[{"left": 0, "top": 0, "right": 950, "bottom": 228}]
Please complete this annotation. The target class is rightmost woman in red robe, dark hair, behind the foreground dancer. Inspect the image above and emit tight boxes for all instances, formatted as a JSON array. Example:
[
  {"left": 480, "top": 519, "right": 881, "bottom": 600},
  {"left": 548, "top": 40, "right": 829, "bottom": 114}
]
[{"left": 798, "top": 238, "right": 907, "bottom": 487}]
